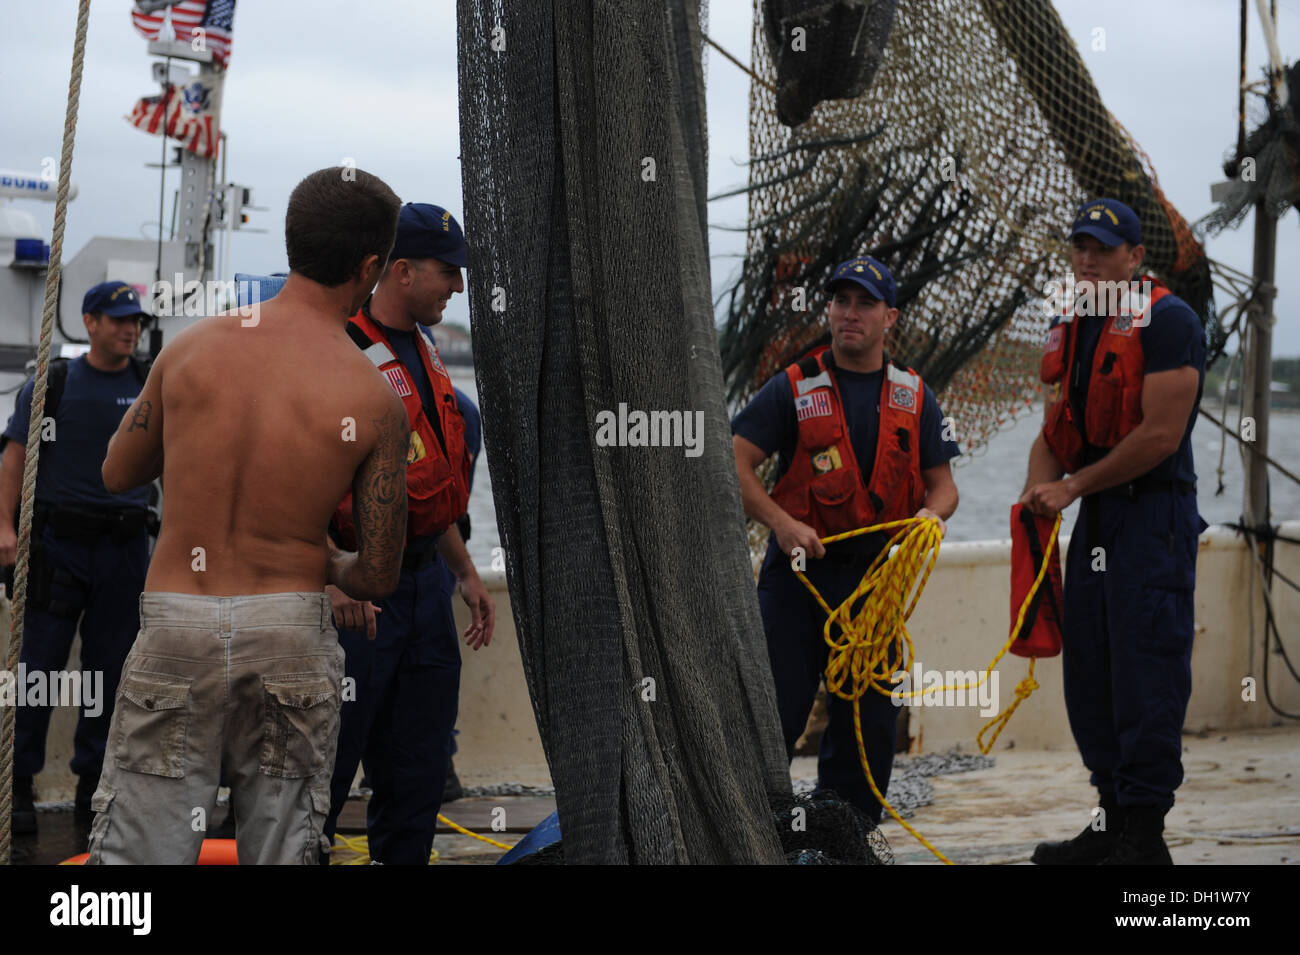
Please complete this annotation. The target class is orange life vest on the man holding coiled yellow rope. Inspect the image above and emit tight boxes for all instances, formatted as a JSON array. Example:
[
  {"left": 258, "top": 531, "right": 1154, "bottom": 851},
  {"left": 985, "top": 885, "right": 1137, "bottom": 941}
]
[{"left": 772, "top": 347, "right": 926, "bottom": 537}]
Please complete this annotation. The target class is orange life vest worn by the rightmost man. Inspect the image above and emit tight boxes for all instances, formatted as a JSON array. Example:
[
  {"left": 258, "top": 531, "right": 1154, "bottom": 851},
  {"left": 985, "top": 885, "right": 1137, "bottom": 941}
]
[{"left": 1039, "top": 275, "right": 1170, "bottom": 474}]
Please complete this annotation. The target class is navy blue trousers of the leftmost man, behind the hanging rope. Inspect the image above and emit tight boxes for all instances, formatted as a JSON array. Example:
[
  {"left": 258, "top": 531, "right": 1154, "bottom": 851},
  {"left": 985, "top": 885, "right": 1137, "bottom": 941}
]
[{"left": 13, "top": 526, "right": 150, "bottom": 777}]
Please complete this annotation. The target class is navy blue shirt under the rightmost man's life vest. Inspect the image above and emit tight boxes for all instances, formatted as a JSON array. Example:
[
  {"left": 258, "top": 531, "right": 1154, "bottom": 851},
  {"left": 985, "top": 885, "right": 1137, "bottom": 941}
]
[{"left": 1071, "top": 295, "right": 1205, "bottom": 482}]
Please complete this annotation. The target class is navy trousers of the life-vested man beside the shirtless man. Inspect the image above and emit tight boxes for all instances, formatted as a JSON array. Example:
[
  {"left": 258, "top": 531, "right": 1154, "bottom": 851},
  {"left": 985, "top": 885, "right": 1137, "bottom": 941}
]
[{"left": 325, "top": 557, "right": 460, "bottom": 865}]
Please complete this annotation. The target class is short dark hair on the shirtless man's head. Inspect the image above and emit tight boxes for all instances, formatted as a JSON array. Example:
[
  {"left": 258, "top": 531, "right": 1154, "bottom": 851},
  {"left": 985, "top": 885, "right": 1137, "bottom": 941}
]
[{"left": 285, "top": 166, "right": 402, "bottom": 288}]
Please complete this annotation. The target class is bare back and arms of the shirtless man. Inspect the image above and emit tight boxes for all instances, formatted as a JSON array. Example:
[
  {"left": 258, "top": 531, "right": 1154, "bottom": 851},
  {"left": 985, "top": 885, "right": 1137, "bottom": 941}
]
[{"left": 104, "top": 294, "right": 410, "bottom": 599}]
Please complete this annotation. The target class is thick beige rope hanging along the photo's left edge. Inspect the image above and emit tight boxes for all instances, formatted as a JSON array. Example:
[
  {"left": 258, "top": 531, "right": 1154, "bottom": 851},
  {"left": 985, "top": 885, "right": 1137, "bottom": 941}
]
[{"left": 0, "top": 0, "right": 90, "bottom": 865}]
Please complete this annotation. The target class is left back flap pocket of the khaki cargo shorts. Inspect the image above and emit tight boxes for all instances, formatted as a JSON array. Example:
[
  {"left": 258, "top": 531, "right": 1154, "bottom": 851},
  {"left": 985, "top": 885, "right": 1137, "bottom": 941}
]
[{"left": 113, "top": 670, "right": 192, "bottom": 780}]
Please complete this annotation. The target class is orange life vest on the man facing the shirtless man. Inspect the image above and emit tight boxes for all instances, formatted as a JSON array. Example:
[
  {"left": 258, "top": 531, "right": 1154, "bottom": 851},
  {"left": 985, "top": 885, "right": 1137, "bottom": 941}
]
[{"left": 334, "top": 308, "right": 471, "bottom": 547}]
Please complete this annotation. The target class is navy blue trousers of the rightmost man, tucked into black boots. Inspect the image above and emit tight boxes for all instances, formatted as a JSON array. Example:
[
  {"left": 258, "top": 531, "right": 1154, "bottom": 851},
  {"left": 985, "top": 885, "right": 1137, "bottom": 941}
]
[{"left": 1062, "top": 491, "right": 1206, "bottom": 808}]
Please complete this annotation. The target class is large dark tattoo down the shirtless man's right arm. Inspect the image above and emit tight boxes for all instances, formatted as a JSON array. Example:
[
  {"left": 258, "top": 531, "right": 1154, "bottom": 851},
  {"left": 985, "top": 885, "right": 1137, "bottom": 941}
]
[{"left": 352, "top": 407, "right": 411, "bottom": 582}]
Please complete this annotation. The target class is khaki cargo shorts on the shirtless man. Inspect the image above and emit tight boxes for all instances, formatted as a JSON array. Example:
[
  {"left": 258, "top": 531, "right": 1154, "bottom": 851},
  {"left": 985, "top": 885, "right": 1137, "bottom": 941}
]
[{"left": 88, "top": 592, "right": 343, "bottom": 865}]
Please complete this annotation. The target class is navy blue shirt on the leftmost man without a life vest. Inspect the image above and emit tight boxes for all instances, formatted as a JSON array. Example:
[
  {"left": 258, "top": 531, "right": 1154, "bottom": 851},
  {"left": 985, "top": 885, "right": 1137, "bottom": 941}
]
[{"left": 4, "top": 355, "right": 150, "bottom": 509}]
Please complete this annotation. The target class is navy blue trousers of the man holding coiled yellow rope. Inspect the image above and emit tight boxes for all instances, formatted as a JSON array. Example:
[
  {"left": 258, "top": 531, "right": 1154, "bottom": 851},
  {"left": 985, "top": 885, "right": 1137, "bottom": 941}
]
[{"left": 758, "top": 542, "right": 900, "bottom": 822}]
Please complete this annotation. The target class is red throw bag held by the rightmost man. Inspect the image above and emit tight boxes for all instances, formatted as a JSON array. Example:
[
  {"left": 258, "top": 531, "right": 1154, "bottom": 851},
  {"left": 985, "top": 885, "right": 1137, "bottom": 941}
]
[{"left": 1011, "top": 504, "right": 1063, "bottom": 656}]
